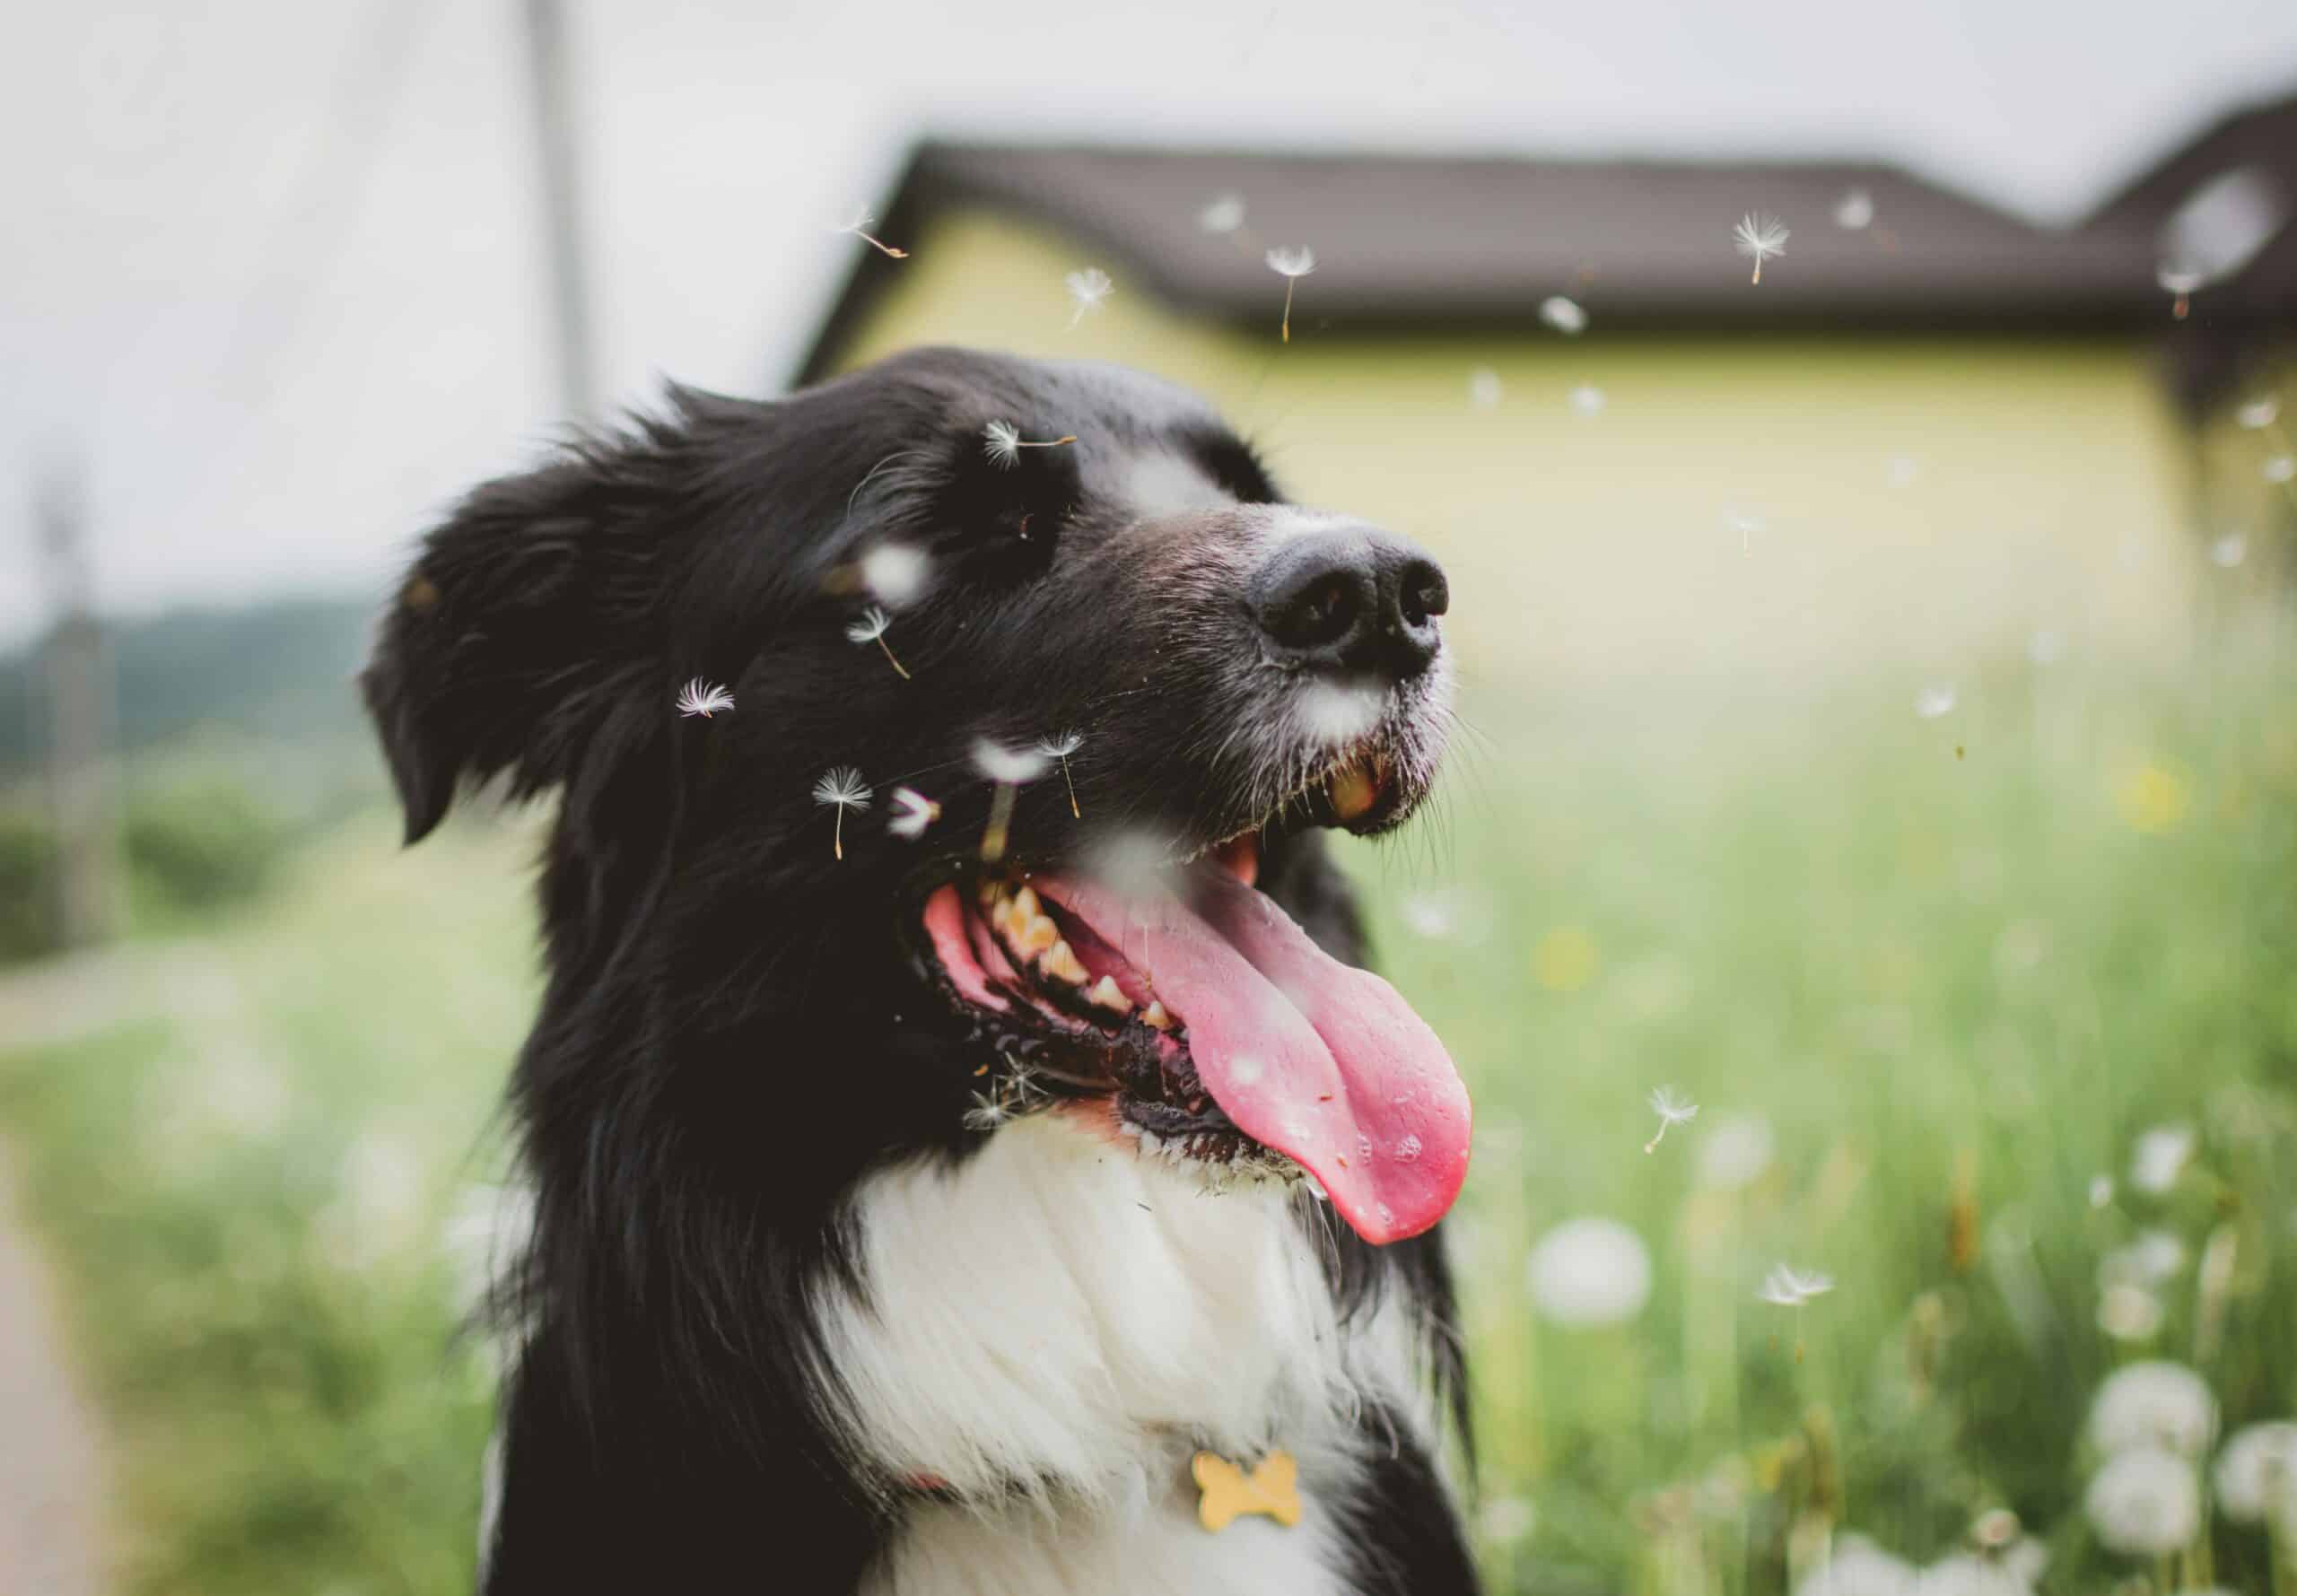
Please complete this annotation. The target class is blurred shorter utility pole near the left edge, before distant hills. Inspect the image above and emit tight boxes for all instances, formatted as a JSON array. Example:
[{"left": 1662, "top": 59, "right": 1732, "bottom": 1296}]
[{"left": 32, "top": 464, "right": 119, "bottom": 948}]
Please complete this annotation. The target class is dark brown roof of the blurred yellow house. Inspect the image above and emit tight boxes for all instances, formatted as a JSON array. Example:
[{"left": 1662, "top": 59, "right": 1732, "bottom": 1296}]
[{"left": 799, "top": 119, "right": 2297, "bottom": 392}]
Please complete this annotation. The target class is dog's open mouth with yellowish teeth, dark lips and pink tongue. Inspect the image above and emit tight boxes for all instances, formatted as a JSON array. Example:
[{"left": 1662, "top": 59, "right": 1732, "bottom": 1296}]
[{"left": 919, "top": 755, "right": 1470, "bottom": 1243}]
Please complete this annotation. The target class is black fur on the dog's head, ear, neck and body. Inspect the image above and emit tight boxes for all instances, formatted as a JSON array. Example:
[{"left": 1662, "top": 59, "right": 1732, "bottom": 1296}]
[{"left": 362, "top": 352, "right": 1470, "bottom": 1596}]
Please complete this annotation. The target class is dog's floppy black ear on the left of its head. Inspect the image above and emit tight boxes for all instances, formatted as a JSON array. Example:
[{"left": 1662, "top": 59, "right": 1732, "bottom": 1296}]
[{"left": 361, "top": 446, "right": 664, "bottom": 842}]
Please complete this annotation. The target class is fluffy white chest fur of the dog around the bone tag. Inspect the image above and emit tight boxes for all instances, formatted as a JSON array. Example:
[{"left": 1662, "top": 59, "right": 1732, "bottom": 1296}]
[{"left": 817, "top": 1113, "right": 1427, "bottom": 1596}]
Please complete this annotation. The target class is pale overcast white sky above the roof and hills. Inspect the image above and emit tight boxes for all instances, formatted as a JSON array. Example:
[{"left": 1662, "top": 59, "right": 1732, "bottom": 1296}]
[{"left": 0, "top": 0, "right": 2297, "bottom": 643}]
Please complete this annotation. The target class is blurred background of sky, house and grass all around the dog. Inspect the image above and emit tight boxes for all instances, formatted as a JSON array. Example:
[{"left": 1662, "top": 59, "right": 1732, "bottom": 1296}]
[{"left": 0, "top": 0, "right": 2297, "bottom": 1596}]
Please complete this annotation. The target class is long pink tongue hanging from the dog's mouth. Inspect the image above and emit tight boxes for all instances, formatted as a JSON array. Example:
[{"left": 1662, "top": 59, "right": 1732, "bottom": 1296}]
[{"left": 1036, "top": 870, "right": 1470, "bottom": 1244}]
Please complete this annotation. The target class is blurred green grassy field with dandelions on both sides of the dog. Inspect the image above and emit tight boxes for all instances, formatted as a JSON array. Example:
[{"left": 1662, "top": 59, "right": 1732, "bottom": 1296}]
[{"left": 0, "top": 643, "right": 2297, "bottom": 1596}]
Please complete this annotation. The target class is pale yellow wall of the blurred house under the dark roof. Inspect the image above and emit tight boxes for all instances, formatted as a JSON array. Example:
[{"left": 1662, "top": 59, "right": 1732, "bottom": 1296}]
[{"left": 845, "top": 214, "right": 2194, "bottom": 680}]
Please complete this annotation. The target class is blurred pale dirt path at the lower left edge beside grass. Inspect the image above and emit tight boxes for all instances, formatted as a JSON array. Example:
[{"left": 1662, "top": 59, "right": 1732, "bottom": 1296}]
[{"left": 0, "top": 1146, "right": 103, "bottom": 1596}]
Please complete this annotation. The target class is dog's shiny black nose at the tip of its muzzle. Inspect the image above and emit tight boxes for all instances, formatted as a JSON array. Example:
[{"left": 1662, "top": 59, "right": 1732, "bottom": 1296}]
[{"left": 1250, "top": 526, "right": 1452, "bottom": 682}]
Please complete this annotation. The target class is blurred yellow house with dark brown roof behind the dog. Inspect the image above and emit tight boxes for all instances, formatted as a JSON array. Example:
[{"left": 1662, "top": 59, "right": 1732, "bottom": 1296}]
[{"left": 797, "top": 99, "right": 2297, "bottom": 680}]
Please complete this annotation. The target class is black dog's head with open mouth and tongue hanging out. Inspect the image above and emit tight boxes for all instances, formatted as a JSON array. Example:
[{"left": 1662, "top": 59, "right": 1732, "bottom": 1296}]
[{"left": 365, "top": 349, "right": 1468, "bottom": 1240}]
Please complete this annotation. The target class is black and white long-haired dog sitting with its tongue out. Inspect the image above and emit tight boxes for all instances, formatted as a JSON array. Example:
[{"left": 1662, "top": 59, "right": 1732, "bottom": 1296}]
[{"left": 362, "top": 349, "right": 1475, "bottom": 1596}]
